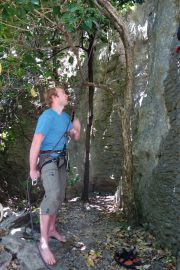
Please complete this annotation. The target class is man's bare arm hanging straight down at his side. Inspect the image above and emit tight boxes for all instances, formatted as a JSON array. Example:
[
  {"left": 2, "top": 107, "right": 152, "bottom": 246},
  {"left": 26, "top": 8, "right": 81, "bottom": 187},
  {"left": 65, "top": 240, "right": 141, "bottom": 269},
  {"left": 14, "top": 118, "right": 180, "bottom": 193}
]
[{"left": 29, "top": 133, "right": 44, "bottom": 179}]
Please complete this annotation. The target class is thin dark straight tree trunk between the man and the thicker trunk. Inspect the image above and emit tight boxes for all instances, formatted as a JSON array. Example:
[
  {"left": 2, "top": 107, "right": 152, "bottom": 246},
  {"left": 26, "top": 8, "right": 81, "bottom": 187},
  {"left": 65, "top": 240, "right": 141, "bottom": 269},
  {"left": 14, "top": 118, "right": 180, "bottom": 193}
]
[{"left": 81, "top": 37, "right": 94, "bottom": 201}]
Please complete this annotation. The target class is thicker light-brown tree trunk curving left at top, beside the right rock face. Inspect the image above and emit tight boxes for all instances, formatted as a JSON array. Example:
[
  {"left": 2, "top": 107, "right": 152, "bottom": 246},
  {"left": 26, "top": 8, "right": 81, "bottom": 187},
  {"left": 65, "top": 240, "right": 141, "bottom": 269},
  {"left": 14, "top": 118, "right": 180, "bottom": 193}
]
[{"left": 93, "top": 0, "right": 137, "bottom": 221}]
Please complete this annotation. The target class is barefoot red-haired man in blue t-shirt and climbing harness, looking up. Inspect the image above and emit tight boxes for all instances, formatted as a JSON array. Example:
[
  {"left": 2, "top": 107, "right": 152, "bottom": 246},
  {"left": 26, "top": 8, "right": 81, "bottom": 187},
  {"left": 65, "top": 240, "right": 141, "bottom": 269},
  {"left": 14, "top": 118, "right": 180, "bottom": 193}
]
[{"left": 29, "top": 88, "right": 80, "bottom": 265}]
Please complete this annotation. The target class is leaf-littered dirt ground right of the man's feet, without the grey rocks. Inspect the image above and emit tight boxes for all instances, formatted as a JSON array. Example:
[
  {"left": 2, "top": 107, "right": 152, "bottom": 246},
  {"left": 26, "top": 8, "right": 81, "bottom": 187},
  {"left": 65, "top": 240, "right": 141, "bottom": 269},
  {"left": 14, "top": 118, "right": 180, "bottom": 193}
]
[{"left": 0, "top": 194, "right": 176, "bottom": 270}]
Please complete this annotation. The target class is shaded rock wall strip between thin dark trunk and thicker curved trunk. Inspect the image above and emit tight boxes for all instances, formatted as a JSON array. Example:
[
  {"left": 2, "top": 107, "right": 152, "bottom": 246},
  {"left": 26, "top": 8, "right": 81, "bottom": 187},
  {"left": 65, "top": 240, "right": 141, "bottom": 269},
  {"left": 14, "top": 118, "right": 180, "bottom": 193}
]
[{"left": 91, "top": 37, "right": 124, "bottom": 191}]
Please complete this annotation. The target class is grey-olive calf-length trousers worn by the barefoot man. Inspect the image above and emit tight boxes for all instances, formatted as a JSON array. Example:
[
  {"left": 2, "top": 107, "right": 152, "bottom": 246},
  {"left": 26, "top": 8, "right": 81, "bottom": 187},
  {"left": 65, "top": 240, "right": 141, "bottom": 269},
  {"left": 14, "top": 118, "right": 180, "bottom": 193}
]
[{"left": 39, "top": 157, "right": 66, "bottom": 215}]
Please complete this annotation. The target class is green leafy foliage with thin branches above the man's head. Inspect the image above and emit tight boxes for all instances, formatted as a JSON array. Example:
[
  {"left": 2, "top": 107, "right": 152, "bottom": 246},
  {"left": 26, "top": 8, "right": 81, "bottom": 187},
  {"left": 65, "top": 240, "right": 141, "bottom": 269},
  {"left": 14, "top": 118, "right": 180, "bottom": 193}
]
[{"left": 0, "top": 0, "right": 142, "bottom": 146}]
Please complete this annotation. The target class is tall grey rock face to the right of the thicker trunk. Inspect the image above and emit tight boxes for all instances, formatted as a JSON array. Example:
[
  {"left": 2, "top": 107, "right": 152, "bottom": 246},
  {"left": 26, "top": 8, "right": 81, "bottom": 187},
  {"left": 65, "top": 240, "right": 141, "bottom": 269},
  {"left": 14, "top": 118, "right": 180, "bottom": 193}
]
[{"left": 131, "top": 0, "right": 180, "bottom": 250}]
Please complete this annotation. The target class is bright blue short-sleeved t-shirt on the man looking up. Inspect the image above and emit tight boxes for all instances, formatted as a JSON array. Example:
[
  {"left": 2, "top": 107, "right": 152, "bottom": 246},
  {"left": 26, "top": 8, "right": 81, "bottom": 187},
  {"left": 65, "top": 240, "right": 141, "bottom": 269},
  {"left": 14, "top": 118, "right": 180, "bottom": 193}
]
[{"left": 35, "top": 108, "right": 73, "bottom": 153}]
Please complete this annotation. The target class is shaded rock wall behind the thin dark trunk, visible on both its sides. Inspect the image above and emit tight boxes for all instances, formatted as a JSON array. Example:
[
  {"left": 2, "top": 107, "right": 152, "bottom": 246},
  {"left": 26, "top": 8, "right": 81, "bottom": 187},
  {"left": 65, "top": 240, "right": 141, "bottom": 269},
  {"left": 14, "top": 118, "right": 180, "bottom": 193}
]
[{"left": 70, "top": 33, "right": 124, "bottom": 191}]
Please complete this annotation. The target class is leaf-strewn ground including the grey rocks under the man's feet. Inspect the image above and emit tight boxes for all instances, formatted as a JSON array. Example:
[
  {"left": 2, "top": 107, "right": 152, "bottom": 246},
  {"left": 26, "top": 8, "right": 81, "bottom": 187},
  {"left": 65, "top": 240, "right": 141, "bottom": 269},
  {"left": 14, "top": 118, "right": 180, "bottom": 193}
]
[{"left": 0, "top": 194, "right": 176, "bottom": 270}]
